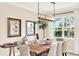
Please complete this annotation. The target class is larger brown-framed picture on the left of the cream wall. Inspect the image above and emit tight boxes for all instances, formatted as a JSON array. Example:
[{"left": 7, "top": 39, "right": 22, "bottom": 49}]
[{"left": 7, "top": 18, "right": 21, "bottom": 37}]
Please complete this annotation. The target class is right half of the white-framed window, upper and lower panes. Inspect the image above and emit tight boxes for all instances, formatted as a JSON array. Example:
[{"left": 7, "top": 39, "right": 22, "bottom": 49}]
[{"left": 64, "top": 17, "right": 75, "bottom": 37}]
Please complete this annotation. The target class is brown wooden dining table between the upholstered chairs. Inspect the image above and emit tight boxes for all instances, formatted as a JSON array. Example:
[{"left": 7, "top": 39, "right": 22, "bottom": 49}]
[{"left": 30, "top": 44, "right": 50, "bottom": 55}]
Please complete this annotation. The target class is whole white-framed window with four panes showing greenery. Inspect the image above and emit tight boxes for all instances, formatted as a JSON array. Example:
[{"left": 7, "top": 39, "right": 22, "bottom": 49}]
[{"left": 52, "top": 16, "right": 75, "bottom": 38}]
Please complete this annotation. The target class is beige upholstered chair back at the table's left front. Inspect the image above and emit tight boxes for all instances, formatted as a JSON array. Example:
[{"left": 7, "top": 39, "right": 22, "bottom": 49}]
[{"left": 19, "top": 45, "right": 30, "bottom": 56}]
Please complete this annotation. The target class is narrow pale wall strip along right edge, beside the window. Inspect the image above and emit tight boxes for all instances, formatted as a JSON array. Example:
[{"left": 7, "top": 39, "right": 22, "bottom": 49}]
[{"left": 74, "top": 10, "right": 79, "bottom": 54}]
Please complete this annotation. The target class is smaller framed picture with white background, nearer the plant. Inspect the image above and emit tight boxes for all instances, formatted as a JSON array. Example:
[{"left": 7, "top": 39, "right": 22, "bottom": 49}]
[{"left": 26, "top": 21, "right": 35, "bottom": 36}]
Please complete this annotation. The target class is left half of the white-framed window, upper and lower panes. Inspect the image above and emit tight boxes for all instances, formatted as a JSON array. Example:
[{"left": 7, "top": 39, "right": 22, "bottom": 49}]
[{"left": 53, "top": 18, "right": 63, "bottom": 37}]
